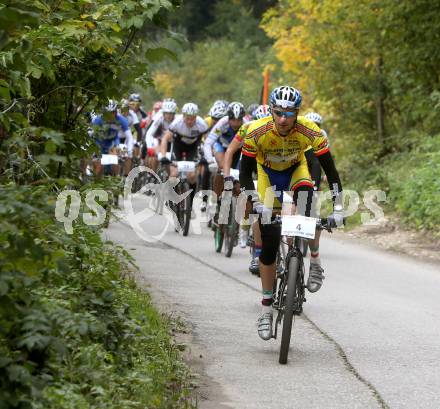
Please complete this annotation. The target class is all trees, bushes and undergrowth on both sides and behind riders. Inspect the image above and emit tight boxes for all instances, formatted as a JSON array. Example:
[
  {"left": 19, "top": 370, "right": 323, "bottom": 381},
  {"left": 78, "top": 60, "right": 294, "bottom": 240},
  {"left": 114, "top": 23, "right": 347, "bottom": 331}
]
[{"left": 0, "top": 0, "right": 440, "bottom": 408}]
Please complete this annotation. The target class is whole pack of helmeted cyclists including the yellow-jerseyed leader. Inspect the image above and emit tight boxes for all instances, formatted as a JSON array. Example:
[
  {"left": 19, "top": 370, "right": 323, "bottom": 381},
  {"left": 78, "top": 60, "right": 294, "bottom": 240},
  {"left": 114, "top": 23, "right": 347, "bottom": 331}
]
[{"left": 90, "top": 86, "right": 343, "bottom": 340}]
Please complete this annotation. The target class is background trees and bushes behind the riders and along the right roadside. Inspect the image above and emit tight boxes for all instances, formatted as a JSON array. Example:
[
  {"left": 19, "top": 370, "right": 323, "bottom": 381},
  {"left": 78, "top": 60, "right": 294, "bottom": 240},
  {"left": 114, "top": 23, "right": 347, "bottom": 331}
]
[{"left": 149, "top": 0, "right": 440, "bottom": 233}]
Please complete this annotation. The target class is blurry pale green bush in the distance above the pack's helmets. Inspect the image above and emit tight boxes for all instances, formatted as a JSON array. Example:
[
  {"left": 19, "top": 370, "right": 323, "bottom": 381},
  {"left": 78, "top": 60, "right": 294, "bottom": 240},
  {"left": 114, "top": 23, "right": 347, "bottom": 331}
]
[{"left": 154, "top": 39, "right": 276, "bottom": 113}]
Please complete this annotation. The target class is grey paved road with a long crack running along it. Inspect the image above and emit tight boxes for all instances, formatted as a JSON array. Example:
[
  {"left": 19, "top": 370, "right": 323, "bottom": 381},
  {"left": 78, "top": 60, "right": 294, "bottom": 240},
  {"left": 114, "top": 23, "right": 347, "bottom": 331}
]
[{"left": 107, "top": 195, "right": 440, "bottom": 409}]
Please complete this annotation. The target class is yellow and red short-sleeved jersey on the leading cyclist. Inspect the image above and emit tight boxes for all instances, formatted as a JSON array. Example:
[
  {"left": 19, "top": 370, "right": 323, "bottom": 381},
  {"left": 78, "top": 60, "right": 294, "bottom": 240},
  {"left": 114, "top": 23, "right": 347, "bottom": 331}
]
[{"left": 242, "top": 116, "right": 329, "bottom": 171}]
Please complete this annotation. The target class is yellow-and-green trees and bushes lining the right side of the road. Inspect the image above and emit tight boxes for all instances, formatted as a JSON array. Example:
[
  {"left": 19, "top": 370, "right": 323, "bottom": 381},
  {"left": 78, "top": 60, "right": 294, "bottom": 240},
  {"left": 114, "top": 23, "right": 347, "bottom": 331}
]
[{"left": 262, "top": 0, "right": 440, "bottom": 232}]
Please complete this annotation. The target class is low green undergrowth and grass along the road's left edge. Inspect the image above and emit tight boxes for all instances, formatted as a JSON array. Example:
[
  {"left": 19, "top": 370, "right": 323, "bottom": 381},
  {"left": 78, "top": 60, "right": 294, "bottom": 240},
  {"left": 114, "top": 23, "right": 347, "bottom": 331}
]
[{"left": 0, "top": 185, "right": 196, "bottom": 409}]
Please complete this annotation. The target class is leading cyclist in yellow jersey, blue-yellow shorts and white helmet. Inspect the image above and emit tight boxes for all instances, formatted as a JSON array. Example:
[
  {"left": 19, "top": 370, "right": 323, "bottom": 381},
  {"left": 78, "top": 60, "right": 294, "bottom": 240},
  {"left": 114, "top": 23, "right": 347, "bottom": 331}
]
[{"left": 240, "top": 86, "right": 343, "bottom": 340}]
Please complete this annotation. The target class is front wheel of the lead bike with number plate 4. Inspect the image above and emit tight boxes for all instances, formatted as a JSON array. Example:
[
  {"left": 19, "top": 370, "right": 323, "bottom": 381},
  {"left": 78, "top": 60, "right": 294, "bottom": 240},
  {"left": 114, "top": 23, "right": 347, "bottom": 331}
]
[{"left": 279, "top": 255, "right": 301, "bottom": 364}]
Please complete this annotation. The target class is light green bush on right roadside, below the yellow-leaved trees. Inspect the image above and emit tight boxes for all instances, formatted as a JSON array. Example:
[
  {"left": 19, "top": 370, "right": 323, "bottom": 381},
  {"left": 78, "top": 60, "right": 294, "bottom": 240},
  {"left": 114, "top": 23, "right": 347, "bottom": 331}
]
[{"left": 339, "top": 133, "right": 440, "bottom": 236}]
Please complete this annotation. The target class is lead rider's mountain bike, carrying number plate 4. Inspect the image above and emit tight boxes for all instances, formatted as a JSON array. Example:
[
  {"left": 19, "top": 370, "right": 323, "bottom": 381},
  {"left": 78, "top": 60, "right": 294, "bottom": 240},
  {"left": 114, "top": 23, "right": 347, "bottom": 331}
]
[{"left": 272, "top": 216, "right": 331, "bottom": 364}]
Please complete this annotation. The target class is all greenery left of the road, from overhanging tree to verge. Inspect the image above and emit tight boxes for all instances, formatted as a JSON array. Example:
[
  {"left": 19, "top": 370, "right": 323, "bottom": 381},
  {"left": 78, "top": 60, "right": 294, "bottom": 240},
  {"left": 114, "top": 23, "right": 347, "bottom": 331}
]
[{"left": 0, "top": 0, "right": 196, "bottom": 409}]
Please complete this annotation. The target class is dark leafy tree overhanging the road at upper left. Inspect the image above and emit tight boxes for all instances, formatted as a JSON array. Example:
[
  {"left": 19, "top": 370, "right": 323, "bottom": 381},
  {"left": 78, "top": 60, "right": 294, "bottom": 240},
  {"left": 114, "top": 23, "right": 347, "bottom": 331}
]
[{"left": 0, "top": 0, "right": 179, "bottom": 180}]
